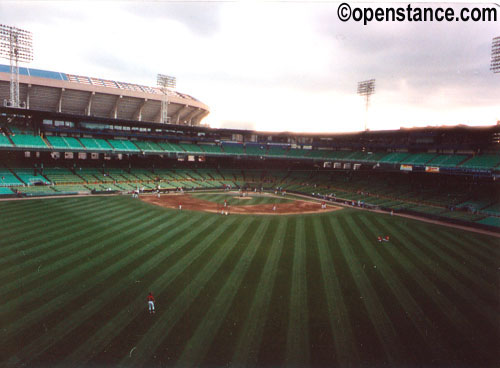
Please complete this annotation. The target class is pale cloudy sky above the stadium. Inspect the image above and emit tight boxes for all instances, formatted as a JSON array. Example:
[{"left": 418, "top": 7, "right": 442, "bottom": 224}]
[{"left": 0, "top": 0, "right": 500, "bottom": 132}]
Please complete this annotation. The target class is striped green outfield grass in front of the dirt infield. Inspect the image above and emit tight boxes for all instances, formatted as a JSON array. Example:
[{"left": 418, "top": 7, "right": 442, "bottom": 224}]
[{"left": 0, "top": 197, "right": 500, "bottom": 367}]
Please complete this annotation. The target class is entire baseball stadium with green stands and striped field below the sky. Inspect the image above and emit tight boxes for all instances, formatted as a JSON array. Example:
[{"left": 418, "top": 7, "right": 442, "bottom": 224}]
[{"left": 0, "top": 23, "right": 500, "bottom": 367}]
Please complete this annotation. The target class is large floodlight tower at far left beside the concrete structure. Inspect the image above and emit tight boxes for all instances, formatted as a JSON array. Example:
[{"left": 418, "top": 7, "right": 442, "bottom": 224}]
[{"left": 0, "top": 24, "right": 33, "bottom": 107}]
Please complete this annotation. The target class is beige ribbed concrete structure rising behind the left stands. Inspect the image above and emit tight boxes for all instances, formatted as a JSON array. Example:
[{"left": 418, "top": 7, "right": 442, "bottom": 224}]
[{"left": 0, "top": 65, "right": 209, "bottom": 126}]
